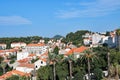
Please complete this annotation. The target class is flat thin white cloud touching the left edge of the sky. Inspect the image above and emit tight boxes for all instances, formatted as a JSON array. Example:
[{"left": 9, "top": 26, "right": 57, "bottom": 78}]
[{"left": 0, "top": 16, "right": 31, "bottom": 25}]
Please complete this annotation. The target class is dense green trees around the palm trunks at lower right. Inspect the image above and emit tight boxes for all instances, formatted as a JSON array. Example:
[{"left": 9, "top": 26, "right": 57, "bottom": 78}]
[{"left": 37, "top": 47, "right": 120, "bottom": 80}]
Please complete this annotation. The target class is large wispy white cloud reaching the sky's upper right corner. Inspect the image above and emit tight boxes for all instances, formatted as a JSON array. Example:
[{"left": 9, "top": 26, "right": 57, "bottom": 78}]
[{"left": 57, "top": 0, "right": 120, "bottom": 18}]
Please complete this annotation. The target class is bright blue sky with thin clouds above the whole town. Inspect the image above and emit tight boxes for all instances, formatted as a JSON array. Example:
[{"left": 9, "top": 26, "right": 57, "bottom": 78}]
[{"left": 0, "top": 0, "right": 120, "bottom": 37}]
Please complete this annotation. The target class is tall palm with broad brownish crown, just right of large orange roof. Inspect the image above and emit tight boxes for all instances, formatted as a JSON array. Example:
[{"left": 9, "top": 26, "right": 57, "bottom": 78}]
[{"left": 80, "top": 48, "right": 97, "bottom": 80}]
